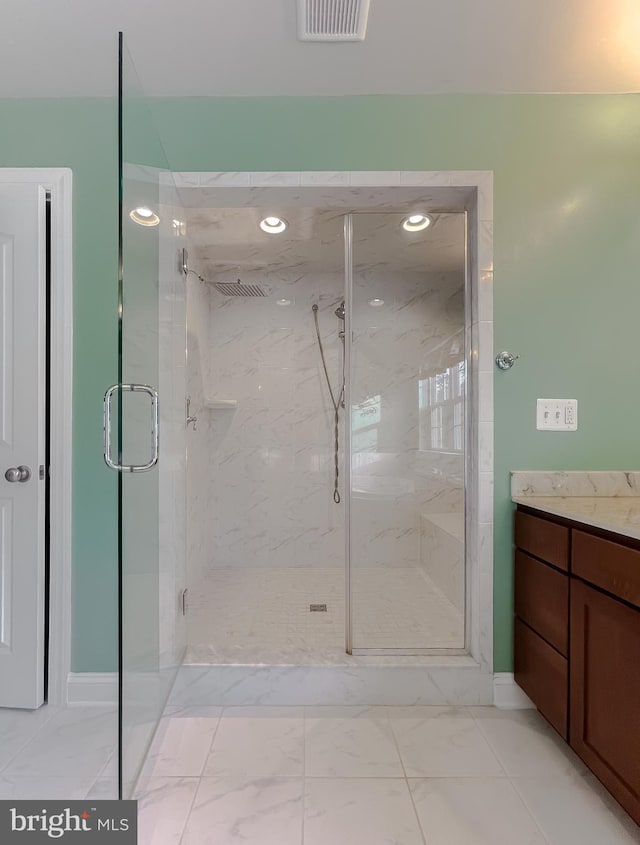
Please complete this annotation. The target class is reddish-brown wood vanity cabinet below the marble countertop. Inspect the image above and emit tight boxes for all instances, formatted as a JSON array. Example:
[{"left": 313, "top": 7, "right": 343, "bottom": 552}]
[{"left": 514, "top": 507, "right": 640, "bottom": 824}]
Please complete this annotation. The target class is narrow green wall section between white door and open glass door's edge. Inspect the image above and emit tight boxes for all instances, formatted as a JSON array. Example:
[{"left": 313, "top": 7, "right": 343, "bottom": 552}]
[{"left": 0, "top": 100, "right": 118, "bottom": 672}]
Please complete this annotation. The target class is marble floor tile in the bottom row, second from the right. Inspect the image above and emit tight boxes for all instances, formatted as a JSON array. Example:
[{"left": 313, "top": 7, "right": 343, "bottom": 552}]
[{"left": 409, "top": 778, "right": 544, "bottom": 845}]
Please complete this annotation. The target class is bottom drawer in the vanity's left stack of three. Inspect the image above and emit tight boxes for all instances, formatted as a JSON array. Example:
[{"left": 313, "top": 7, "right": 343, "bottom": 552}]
[{"left": 514, "top": 619, "right": 568, "bottom": 739}]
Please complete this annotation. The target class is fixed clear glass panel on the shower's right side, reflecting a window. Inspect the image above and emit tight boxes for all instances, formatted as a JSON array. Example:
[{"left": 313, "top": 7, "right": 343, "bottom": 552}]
[{"left": 347, "top": 212, "right": 468, "bottom": 653}]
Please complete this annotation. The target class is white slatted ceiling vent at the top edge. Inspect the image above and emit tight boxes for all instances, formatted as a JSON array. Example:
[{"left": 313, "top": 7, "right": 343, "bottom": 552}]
[{"left": 298, "top": 0, "right": 369, "bottom": 41}]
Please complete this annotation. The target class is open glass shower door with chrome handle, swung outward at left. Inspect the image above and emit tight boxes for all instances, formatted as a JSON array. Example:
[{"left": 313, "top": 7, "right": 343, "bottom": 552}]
[{"left": 112, "top": 36, "right": 185, "bottom": 797}]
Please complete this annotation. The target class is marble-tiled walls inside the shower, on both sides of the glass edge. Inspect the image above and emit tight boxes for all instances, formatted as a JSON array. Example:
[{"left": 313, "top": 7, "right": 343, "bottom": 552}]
[{"left": 187, "top": 258, "right": 464, "bottom": 572}]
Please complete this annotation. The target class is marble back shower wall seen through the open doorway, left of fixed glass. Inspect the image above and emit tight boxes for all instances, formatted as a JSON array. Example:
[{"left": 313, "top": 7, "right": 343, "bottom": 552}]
[{"left": 206, "top": 271, "right": 344, "bottom": 567}]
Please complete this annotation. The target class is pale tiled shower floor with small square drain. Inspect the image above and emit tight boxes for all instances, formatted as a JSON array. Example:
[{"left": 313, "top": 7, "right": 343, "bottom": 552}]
[{"left": 186, "top": 567, "right": 464, "bottom": 662}]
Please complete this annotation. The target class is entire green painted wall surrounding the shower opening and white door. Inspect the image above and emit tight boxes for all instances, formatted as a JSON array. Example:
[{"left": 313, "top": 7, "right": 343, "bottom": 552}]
[{"left": 0, "top": 95, "right": 640, "bottom": 671}]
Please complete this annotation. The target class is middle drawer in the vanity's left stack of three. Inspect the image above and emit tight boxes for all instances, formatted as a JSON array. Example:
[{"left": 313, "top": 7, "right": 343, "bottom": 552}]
[{"left": 515, "top": 550, "right": 569, "bottom": 657}]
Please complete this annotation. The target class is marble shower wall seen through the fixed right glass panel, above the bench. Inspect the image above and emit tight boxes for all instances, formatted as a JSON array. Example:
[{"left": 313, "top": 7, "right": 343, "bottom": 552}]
[{"left": 351, "top": 268, "right": 465, "bottom": 566}]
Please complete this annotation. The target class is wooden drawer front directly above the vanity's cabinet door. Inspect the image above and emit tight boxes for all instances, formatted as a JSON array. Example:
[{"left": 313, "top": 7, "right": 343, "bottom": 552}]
[{"left": 571, "top": 530, "right": 640, "bottom": 607}]
